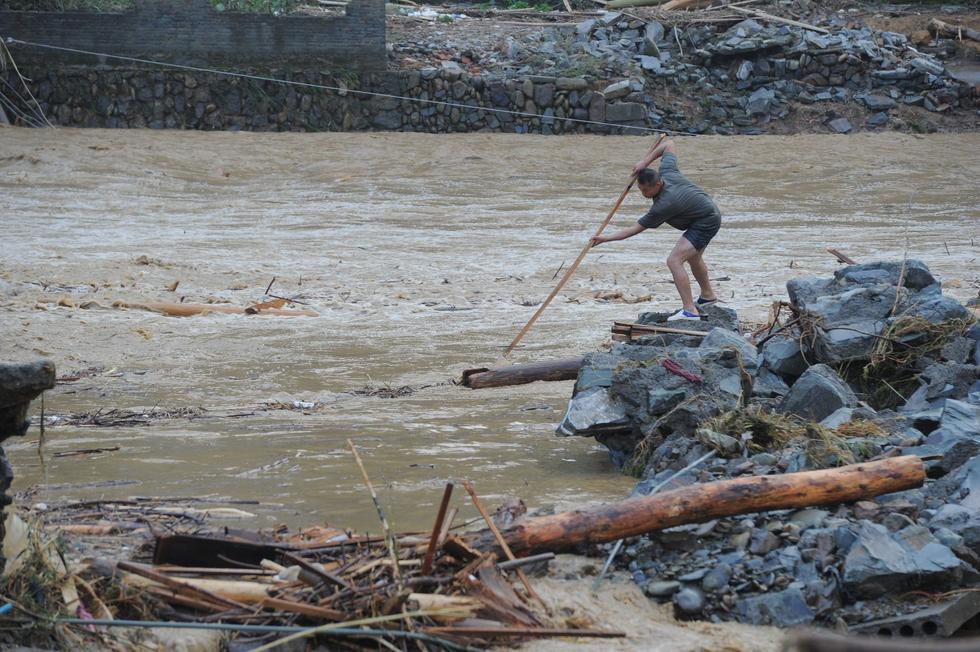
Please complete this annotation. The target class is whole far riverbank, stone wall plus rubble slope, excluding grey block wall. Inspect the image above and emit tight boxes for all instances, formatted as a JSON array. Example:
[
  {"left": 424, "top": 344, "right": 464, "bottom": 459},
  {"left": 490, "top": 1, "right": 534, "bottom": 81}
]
[{"left": 5, "top": 3, "right": 980, "bottom": 135}]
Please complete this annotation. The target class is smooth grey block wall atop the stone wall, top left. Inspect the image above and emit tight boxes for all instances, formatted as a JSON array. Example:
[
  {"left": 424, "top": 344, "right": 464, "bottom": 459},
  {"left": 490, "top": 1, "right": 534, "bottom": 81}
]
[{"left": 0, "top": 0, "right": 386, "bottom": 70}]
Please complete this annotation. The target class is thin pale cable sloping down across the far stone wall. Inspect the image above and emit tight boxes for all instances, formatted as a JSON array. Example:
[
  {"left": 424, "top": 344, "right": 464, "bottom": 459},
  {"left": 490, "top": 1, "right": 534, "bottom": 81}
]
[{"left": 6, "top": 36, "right": 694, "bottom": 136}]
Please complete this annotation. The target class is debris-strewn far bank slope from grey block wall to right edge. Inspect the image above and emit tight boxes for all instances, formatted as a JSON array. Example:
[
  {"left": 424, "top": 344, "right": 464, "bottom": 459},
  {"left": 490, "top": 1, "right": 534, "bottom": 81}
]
[{"left": 389, "top": 2, "right": 978, "bottom": 134}]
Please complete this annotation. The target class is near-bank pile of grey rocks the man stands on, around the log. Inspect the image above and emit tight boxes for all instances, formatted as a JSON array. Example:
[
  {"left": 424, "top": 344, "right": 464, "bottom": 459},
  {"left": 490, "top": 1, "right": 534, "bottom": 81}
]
[{"left": 559, "top": 260, "right": 980, "bottom": 635}]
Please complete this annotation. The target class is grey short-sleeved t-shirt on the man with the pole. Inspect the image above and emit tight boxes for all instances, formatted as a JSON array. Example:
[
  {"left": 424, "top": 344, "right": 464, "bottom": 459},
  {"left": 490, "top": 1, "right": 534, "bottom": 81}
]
[{"left": 638, "top": 152, "right": 721, "bottom": 231}]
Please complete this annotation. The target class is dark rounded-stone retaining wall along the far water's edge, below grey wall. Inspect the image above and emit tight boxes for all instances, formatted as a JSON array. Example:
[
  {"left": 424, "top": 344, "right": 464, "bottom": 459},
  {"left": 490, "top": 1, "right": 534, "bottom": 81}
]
[{"left": 0, "top": 67, "right": 628, "bottom": 134}]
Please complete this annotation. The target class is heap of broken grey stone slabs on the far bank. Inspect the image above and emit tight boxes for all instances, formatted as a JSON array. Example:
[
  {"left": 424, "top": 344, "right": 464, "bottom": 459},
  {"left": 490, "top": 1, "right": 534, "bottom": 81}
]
[{"left": 571, "top": 12, "right": 973, "bottom": 133}]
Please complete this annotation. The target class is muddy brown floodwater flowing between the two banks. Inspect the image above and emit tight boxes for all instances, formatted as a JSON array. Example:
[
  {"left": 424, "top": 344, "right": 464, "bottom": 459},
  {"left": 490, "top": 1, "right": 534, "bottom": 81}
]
[{"left": 0, "top": 129, "right": 980, "bottom": 530}]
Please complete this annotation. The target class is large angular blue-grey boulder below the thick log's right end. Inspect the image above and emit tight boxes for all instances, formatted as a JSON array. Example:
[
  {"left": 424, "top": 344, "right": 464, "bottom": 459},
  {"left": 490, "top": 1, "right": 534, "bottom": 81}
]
[{"left": 843, "top": 521, "right": 976, "bottom": 598}]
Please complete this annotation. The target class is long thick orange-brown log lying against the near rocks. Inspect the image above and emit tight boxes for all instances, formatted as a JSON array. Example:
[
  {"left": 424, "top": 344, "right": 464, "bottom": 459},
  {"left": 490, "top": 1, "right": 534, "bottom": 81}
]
[{"left": 471, "top": 455, "right": 926, "bottom": 556}]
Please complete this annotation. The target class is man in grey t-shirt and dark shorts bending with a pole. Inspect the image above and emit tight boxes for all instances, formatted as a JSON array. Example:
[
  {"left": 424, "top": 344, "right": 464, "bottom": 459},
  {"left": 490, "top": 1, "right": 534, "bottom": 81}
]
[{"left": 592, "top": 140, "right": 721, "bottom": 321}]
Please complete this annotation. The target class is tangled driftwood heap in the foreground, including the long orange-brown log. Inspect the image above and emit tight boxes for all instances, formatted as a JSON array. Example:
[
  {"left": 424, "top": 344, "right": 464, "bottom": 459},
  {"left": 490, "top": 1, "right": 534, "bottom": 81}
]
[{"left": 4, "top": 446, "right": 925, "bottom": 650}]
